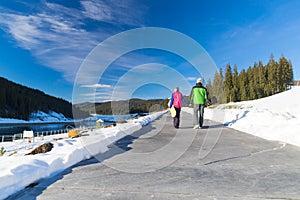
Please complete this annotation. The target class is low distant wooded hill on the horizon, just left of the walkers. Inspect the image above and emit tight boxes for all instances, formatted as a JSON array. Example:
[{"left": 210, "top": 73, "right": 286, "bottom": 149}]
[{"left": 75, "top": 98, "right": 169, "bottom": 115}]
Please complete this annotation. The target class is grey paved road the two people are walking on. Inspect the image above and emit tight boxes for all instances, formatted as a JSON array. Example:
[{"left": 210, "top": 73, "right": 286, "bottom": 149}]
[{"left": 7, "top": 113, "right": 300, "bottom": 200}]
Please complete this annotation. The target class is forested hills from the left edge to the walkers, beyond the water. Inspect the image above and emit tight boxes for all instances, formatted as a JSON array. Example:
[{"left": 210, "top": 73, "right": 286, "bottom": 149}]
[{"left": 0, "top": 77, "right": 169, "bottom": 120}]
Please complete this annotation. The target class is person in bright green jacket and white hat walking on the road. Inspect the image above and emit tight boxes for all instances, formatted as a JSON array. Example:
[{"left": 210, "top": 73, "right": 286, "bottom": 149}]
[{"left": 190, "top": 78, "right": 207, "bottom": 129}]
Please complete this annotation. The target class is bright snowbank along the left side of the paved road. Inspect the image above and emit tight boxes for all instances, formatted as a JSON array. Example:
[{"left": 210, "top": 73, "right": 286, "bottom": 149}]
[{"left": 0, "top": 111, "right": 166, "bottom": 199}]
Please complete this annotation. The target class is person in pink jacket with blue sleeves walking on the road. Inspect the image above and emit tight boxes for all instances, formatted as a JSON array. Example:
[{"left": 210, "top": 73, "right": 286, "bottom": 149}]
[{"left": 169, "top": 87, "right": 188, "bottom": 128}]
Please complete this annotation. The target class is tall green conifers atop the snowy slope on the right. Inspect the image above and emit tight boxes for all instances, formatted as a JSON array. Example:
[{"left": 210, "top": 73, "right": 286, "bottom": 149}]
[{"left": 206, "top": 54, "right": 293, "bottom": 103}]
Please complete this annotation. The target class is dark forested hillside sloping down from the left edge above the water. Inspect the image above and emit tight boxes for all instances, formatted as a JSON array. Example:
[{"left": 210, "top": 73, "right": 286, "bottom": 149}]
[{"left": 0, "top": 77, "right": 88, "bottom": 120}]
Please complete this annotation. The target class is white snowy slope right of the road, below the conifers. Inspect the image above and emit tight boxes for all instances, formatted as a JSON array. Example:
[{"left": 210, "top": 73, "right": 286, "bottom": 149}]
[{"left": 184, "top": 87, "right": 300, "bottom": 146}]
